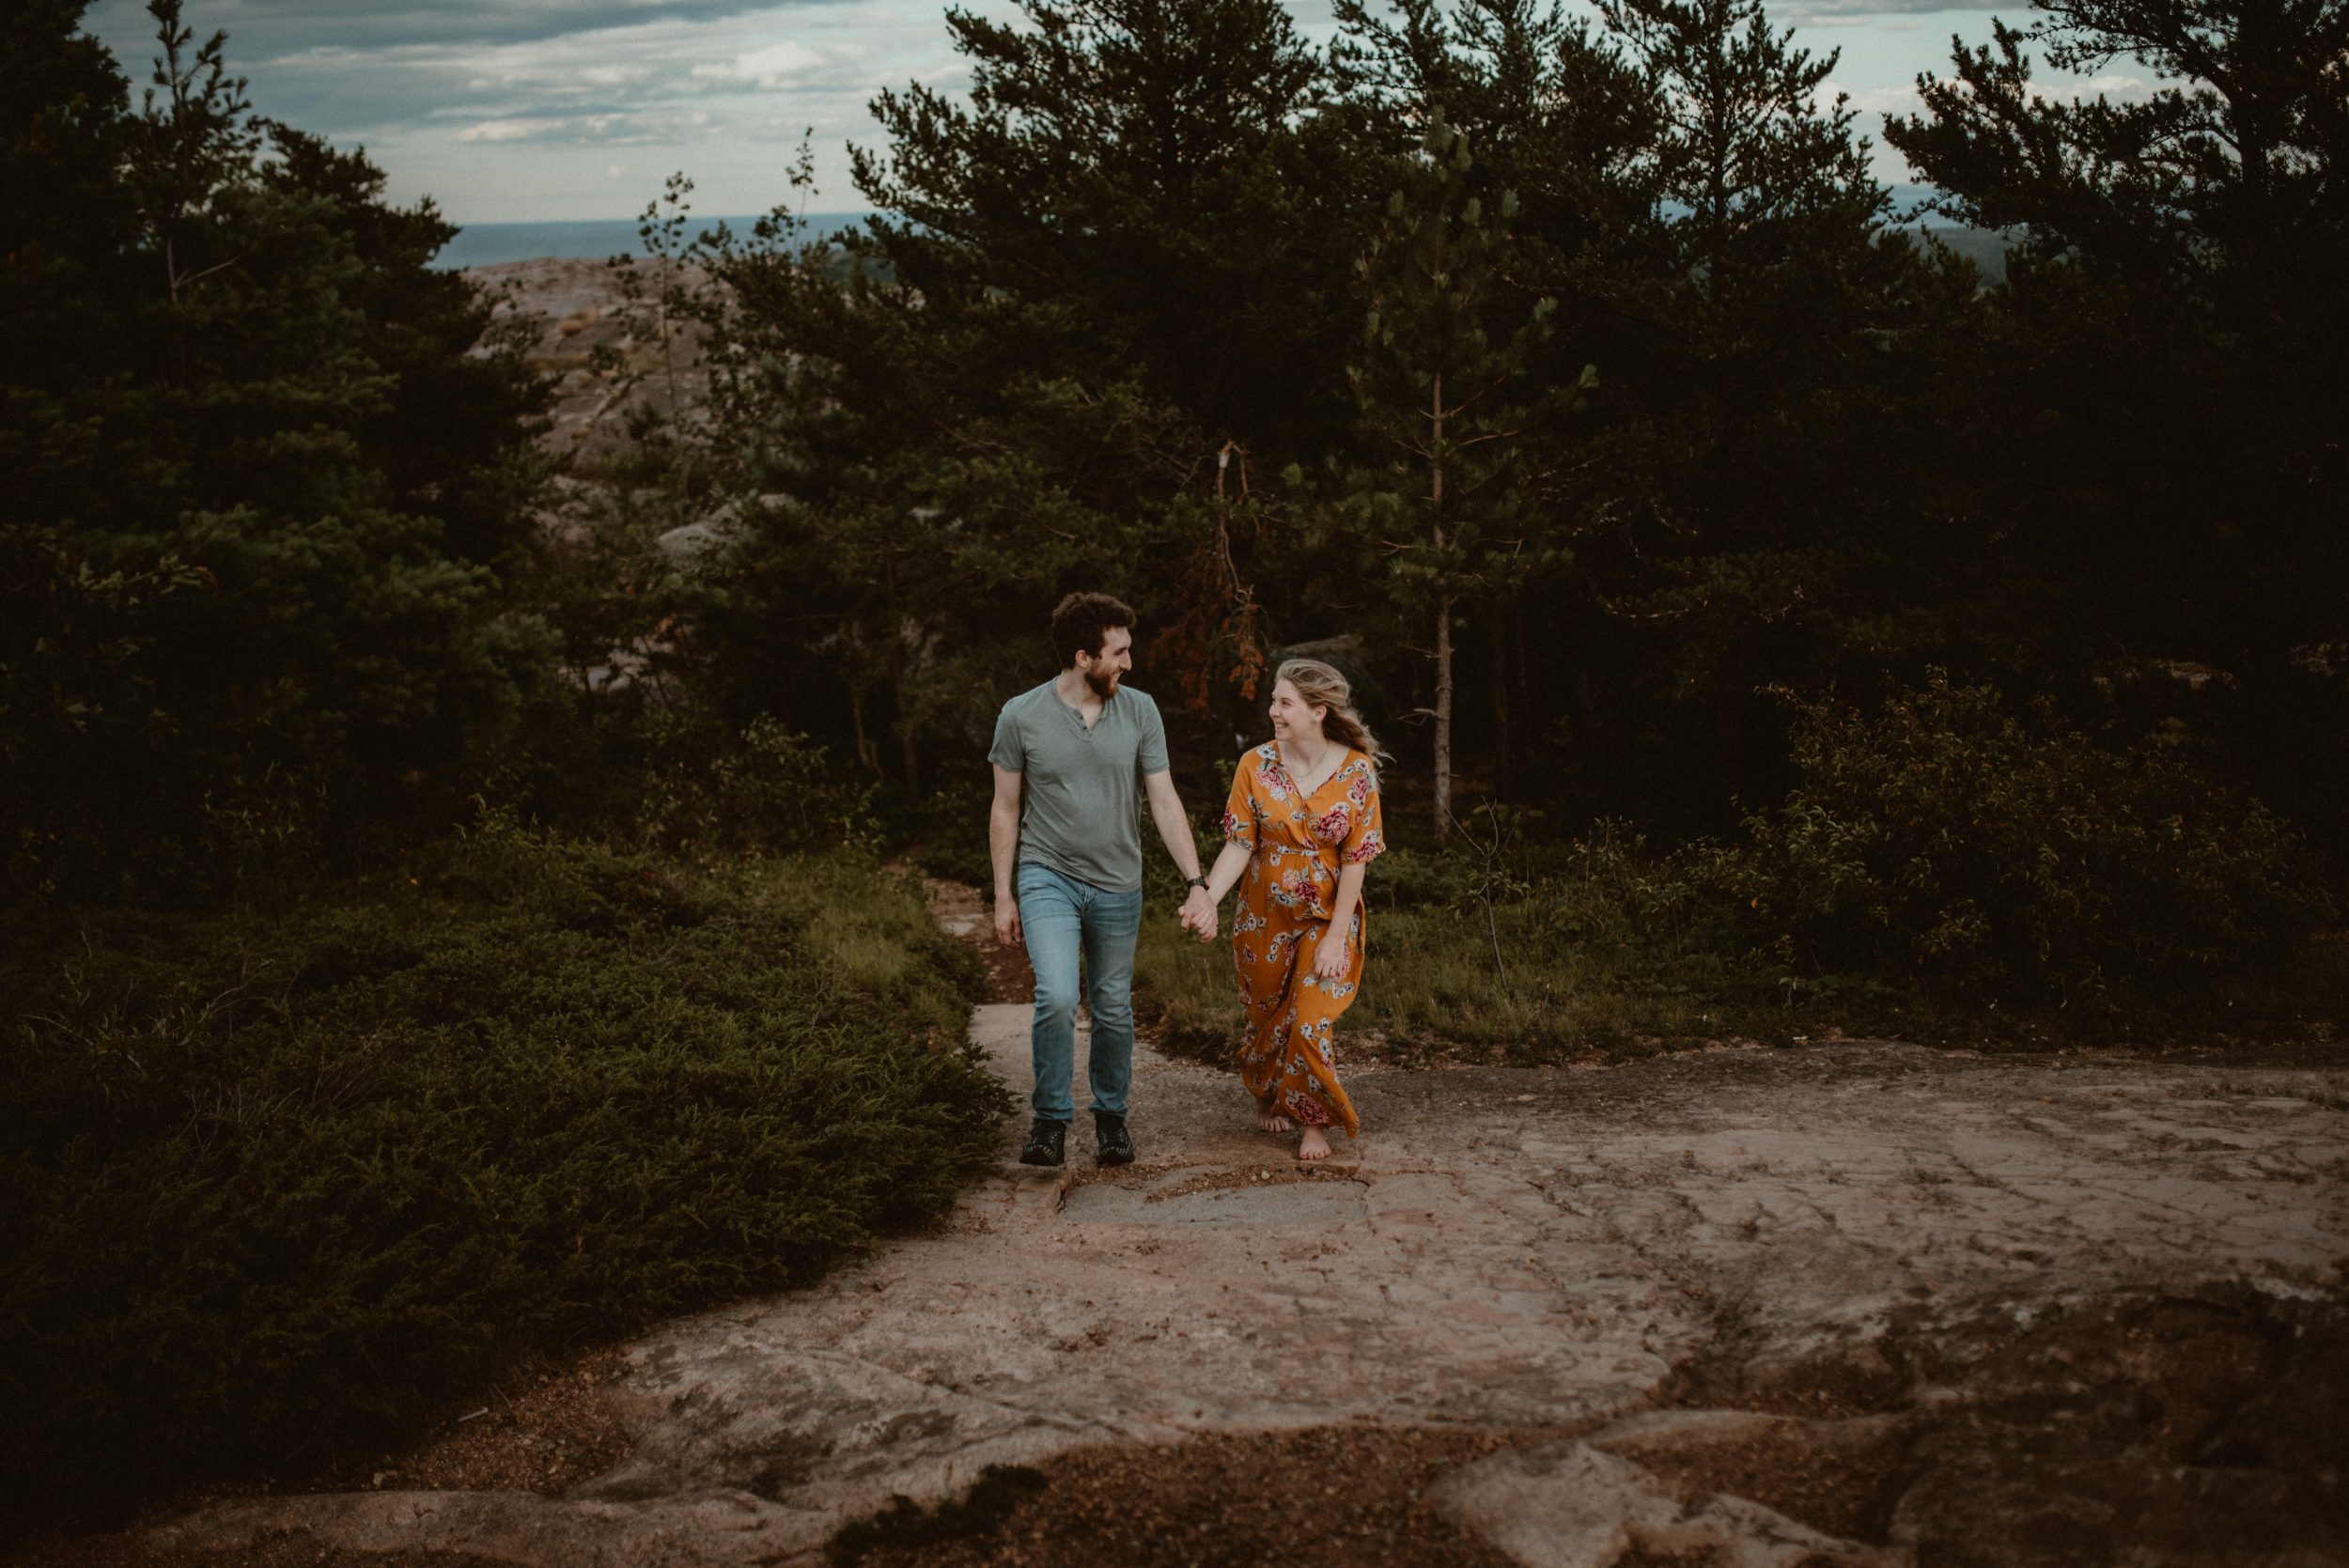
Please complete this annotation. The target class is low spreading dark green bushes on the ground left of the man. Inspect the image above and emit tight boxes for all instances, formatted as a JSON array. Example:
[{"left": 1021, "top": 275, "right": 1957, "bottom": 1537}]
[{"left": 0, "top": 821, "right": 1008, "bottom": 1519}]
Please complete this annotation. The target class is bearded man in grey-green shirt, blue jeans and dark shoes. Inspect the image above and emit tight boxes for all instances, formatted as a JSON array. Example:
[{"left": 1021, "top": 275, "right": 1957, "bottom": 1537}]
[{"left": 987, "top": 594, "right": 1215, "bottom": 1164}]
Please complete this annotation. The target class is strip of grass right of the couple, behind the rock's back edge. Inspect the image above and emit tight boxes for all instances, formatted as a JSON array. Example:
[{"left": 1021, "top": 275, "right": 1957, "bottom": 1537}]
[{"left": 1135, "top": 840, "right": 2349, "bottom": 1065}]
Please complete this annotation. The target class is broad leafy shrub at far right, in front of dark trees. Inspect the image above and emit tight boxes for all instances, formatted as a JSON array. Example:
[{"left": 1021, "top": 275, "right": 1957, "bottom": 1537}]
[{"left": 1708, "top": 674, "right": 2330, "bottom": 1000}]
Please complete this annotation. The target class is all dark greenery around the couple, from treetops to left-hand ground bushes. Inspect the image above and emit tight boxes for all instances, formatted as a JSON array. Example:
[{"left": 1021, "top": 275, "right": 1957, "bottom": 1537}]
[{"left": 0, "top": 0, "right": 2349, "bottom": 1530}]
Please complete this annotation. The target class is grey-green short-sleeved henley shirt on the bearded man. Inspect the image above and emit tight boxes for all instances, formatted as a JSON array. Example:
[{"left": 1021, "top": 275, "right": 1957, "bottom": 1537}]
[{"left": 987, "top": 681, "right": 1168, "bottom": 892}]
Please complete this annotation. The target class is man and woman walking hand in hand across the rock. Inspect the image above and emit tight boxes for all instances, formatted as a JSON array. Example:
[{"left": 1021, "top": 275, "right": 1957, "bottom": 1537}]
[{"left": 987, "top": 594, "right": 1386, "bottom": 1164}]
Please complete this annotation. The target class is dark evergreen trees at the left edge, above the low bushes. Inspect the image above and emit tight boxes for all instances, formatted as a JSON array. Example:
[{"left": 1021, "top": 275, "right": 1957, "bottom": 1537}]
[{"left": 0, "top": 0, "right": 548, "bottom": 894}]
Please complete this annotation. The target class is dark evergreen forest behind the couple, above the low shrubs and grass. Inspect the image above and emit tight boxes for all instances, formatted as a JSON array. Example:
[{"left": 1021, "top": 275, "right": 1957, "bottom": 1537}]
[{"left": 0, "top": 0, "right": 2349, "bottom": 920}]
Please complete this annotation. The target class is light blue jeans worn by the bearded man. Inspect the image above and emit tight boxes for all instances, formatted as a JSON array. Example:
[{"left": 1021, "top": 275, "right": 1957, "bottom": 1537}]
[{"left": 1019, "top": 862, "right": 1142, "bottom": 1122}]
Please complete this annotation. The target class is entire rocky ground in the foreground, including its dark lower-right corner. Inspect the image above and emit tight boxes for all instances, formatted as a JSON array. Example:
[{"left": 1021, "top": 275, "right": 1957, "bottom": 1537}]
[{"left": 83, "top": 887, "right": 2349, "bottom": 1568}]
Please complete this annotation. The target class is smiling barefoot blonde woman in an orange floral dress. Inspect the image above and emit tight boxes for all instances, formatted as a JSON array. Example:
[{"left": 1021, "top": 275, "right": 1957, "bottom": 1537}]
[{"left": 1207, "top": 660, "right": 1386, "bottom": 1159}]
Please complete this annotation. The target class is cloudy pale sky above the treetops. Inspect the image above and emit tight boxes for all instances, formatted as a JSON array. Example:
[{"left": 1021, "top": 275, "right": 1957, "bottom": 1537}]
[{"left": 83, "top": 0, "right": 2147, "bottom": 223}]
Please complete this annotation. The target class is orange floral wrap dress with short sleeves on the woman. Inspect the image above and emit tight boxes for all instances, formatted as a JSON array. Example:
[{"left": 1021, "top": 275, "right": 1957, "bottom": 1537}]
[{"left": 1224, "top": 742, "right": 1386, "bottom": 1139}]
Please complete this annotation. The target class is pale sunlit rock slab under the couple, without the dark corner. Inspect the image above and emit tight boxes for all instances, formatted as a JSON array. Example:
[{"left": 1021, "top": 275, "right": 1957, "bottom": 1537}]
[{"left": 137, "top": 1007, "right": 2349, "bottom": 1568}]
